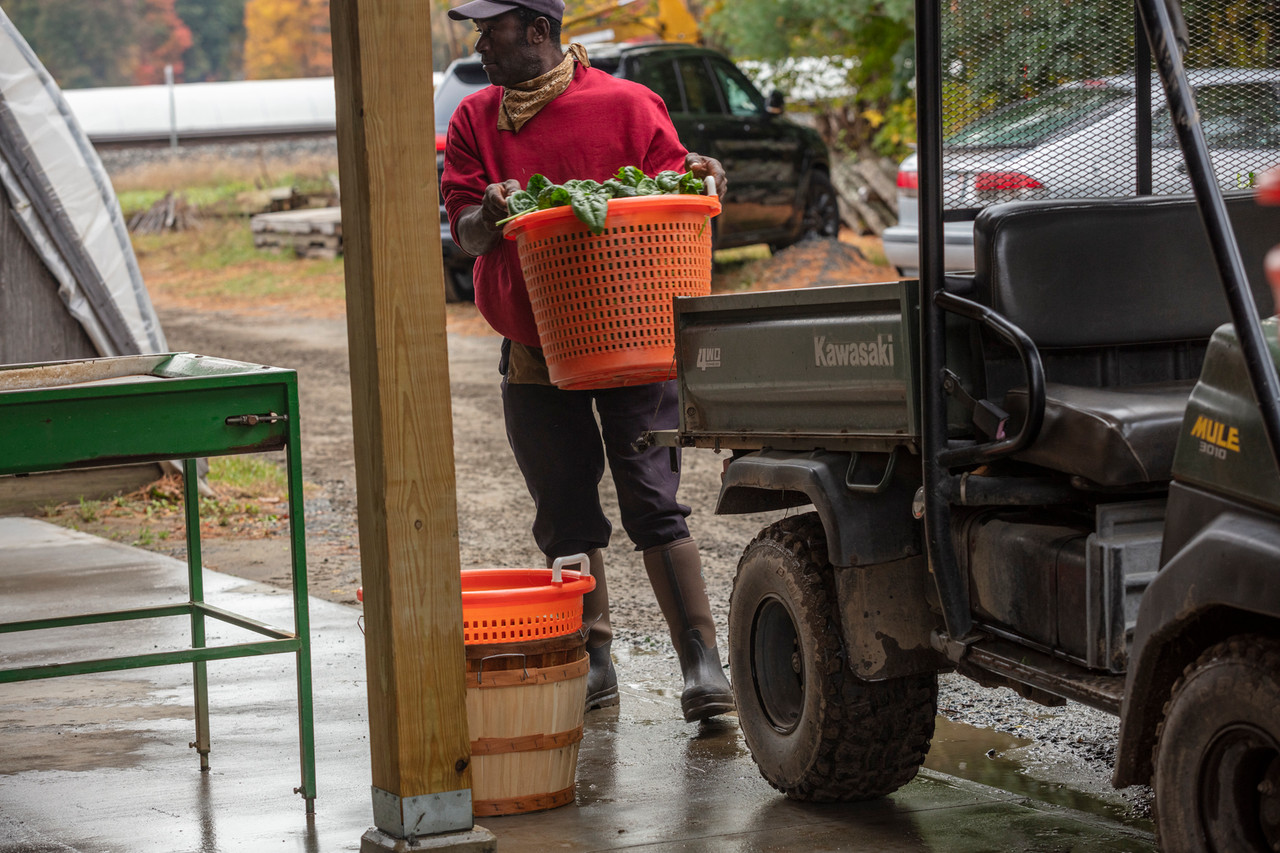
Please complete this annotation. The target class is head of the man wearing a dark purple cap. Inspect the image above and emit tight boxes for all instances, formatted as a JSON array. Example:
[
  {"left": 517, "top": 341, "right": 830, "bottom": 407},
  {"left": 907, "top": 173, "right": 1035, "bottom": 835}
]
[{"left": 449, "top": 0, "right": 564, "bottom": 86}]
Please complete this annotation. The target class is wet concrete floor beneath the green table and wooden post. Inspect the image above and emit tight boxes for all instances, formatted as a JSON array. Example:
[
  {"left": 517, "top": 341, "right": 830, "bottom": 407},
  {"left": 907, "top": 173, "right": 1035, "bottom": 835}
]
[{"left": 0, "top": 519, "right": 1153, "bottom": 853}]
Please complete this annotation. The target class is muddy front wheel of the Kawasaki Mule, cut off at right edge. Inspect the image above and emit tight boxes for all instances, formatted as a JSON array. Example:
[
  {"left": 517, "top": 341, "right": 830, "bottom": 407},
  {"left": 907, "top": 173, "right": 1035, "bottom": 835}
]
[{"left": 1153, "top": 635, "right": 1280, "bottom": 853}]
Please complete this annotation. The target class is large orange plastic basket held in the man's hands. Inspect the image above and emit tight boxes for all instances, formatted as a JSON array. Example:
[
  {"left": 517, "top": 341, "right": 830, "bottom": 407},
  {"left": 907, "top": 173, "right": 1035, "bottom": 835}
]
[{"left": 504, "top": 195, "right": 721, "bottom": 389}]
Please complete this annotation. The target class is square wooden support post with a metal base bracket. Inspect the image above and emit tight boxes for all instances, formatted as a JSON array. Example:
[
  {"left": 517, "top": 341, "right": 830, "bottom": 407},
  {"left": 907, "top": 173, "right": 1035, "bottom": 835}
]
[{"left": 330, "top": 0, "right": 497, "bottom": 850}]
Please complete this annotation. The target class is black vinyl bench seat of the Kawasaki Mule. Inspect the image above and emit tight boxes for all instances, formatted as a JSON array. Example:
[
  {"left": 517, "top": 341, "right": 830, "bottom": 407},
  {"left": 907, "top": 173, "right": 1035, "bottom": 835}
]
[{"left": 973, "top": 193, "right": 1280, "bottom": 487}]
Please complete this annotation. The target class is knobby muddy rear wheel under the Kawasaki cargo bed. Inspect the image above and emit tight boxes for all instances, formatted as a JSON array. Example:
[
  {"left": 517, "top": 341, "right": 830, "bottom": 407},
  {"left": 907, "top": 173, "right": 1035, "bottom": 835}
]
[{"left": 728, "top": 512, "right": 938, "bottom": 802}]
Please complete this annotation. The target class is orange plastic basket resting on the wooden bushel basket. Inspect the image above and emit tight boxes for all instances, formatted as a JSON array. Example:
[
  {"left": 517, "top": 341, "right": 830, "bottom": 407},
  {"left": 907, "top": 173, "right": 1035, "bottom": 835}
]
[{"left": 462, "top": 555, "right": 595, "bottom": 646}]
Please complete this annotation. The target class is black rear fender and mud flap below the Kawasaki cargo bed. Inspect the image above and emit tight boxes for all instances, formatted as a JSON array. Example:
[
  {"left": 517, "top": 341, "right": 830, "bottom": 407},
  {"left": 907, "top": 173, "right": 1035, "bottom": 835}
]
[{"left": 716, "top": 448, "right": 923, "bottom": 567}]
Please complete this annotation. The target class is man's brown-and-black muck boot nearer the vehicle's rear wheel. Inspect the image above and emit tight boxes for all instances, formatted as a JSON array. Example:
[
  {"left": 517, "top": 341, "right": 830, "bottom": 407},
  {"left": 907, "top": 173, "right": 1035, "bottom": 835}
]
[{"left": 644, "top": 539, "right": 733, "bottom": 722}]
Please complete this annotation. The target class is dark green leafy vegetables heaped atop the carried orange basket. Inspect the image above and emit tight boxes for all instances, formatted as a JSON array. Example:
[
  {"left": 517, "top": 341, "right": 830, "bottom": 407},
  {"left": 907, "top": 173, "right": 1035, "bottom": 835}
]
[{"left": 498, "top": 167, "right": 703, "bottom": 234}]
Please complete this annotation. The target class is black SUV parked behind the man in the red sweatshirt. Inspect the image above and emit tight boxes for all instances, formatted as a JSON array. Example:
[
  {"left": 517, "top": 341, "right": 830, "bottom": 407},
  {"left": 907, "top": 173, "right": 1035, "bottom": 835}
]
[{"left": 435, "top": 42, "right": 840, "bottom": 298}]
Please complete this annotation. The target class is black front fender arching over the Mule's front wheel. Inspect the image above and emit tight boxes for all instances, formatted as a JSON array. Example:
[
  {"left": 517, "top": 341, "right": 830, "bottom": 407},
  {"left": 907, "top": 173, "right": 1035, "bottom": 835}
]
[{"left": 1112, "top": 510, "right": 1280, "bottom": 788}]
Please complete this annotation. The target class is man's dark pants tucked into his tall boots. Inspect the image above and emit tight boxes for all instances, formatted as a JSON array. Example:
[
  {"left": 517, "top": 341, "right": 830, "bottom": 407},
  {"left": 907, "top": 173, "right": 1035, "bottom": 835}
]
[{"left": 502, "top": 379, "right": 689, "bottom": 557}]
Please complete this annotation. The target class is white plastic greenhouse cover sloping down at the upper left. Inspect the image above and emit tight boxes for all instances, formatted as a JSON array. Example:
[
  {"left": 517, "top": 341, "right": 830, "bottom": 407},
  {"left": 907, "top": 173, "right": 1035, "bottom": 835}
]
[{"left": 0, "top": 10, "right": 168, "bottom": 356}]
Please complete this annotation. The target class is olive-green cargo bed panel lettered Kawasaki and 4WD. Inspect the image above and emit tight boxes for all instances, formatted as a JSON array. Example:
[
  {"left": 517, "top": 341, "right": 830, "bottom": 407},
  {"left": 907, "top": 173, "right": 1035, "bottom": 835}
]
[{"left": 676, "top": 280, "right": 920, "bottom": 451}]
